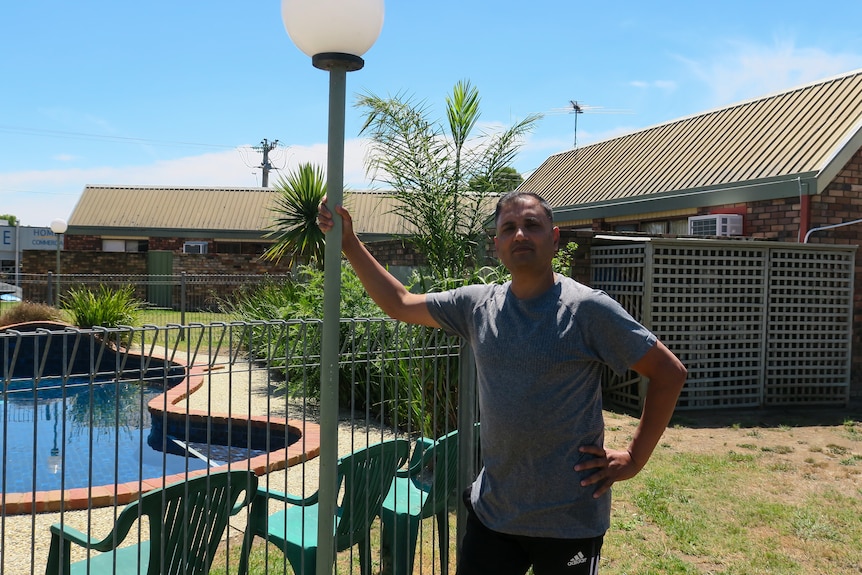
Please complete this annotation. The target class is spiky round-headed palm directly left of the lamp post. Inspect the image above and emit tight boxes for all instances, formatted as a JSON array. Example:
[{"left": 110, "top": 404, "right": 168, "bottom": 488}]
[{"left": 263, "top": 164, "right": 326, "bottom": 266}]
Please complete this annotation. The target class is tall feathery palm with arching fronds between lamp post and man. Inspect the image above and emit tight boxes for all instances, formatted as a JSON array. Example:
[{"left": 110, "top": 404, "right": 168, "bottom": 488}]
[{"left": 356, "top": 81, "right": 540, "bottom": 285}]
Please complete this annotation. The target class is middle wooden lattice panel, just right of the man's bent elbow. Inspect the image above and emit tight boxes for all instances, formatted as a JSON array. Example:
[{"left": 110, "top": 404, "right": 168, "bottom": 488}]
[{"left": 646, "top": 242, "right": 766, "bottom": 409}]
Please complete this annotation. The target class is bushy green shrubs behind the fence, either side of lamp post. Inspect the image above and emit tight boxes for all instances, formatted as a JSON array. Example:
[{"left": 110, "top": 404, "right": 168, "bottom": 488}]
[{"left": 224, "top": 265, "right": 458, "bottom": 436}]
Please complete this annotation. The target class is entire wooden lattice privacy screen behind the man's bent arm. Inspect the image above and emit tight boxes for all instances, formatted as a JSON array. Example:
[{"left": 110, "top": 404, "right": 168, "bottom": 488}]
[{"left": 591, "top": 239, "right": 855, "bottom": 409}]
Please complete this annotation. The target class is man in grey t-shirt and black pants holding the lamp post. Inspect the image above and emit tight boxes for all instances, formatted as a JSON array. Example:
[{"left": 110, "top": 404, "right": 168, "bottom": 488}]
[{"left": 318, "top": 191, "right": 686, "bottom": 575}]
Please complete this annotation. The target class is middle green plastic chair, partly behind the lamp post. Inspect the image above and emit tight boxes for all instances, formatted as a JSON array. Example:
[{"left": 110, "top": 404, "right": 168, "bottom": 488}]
[{"left": 237, "top": 439, "right": 410, "bottom": 575}]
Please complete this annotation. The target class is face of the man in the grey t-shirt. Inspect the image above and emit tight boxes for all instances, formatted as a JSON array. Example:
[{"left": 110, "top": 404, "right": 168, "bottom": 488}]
[{"left": 494, "top": 196, "right": 560, "bottom": 274}]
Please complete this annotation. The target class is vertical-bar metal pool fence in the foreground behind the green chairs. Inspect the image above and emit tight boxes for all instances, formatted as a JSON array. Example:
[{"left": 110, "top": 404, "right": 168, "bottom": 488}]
[{"left": 0, "top": 319, "right": 477, "bottom": 575}]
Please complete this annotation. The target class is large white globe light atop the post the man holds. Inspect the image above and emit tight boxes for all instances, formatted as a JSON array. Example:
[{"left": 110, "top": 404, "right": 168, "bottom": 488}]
[{"left": 281, "top": 0, "right": 383, "bottom": 56}]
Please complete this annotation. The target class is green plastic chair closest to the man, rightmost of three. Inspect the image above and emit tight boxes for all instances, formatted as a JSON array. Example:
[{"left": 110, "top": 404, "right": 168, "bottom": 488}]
[{"left": 380, "top": 424, "right": 479, "bottom": 575}]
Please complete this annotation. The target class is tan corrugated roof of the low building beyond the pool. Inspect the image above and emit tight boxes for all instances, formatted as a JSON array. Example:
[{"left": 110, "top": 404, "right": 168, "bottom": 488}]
[{"left": 69, "top": 186, "right": 418, "bottom": 235}]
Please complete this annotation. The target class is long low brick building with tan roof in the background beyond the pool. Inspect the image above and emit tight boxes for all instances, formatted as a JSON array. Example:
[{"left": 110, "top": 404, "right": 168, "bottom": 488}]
[{"left": 44, "top": 186, "right": 426, "bottom": 276}]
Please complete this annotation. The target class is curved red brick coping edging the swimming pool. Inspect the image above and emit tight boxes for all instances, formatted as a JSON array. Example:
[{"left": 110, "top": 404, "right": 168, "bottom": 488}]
[{"left": 0, "top": 356, "right": 320, "bottom": 515}]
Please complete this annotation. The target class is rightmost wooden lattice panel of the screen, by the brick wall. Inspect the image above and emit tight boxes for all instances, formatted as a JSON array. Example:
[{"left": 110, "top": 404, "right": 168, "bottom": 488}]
[{"left": 764, "top": 249, "right": 854, "bottom": 405}]
